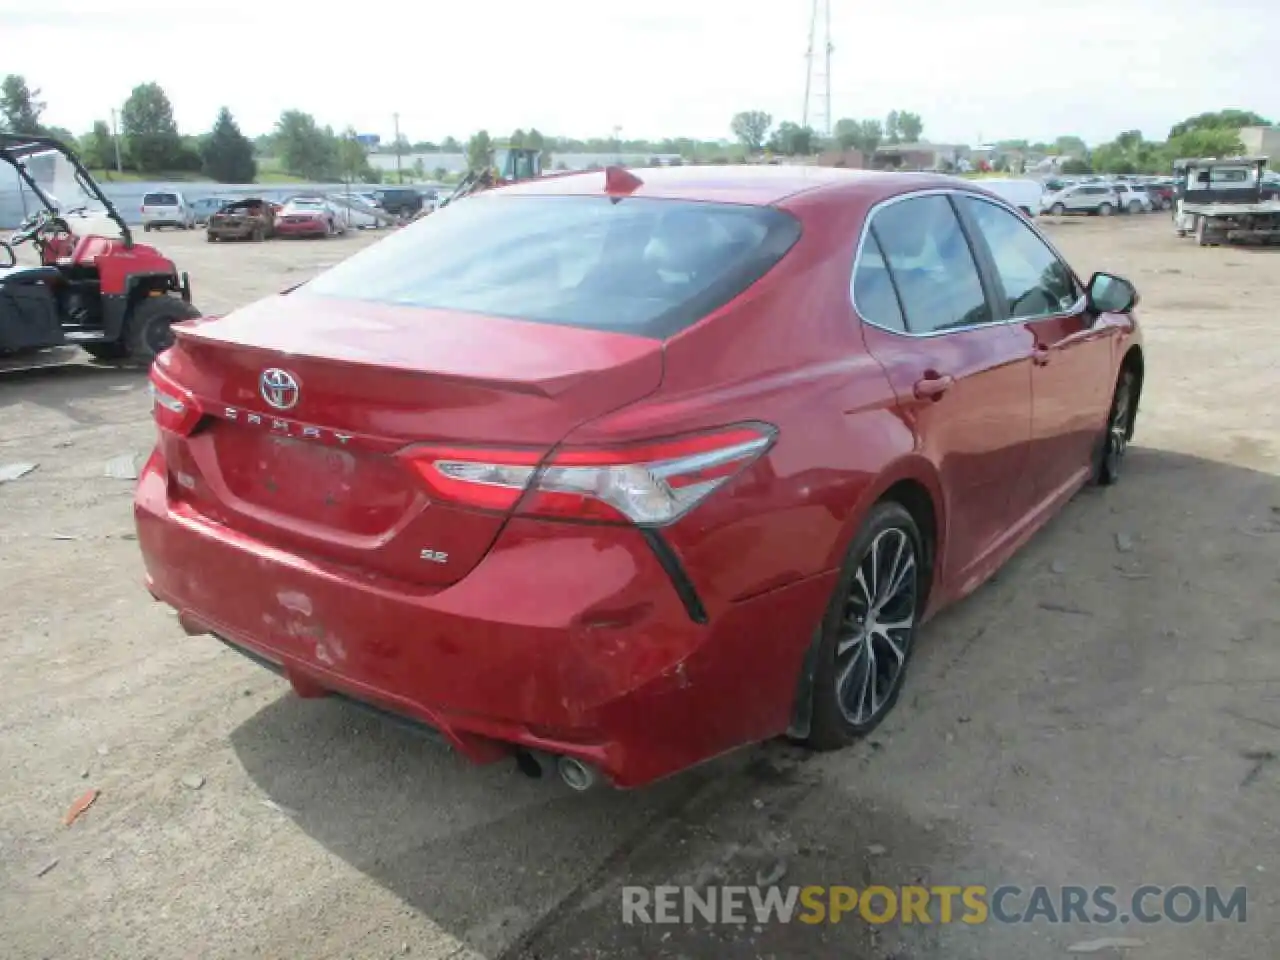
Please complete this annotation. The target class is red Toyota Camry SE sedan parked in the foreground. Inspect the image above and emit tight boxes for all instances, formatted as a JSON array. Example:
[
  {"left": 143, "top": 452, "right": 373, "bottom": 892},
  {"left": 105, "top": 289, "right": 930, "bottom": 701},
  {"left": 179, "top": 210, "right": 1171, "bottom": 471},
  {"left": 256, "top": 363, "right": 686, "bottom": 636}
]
[{"left": 136, "top": 166, "right": 1144, "bottom": 787}]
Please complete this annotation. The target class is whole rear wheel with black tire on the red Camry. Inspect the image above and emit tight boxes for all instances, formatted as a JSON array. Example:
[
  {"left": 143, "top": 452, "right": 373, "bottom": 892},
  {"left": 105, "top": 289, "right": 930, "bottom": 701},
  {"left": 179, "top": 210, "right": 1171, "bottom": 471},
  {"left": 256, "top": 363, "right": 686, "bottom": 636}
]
[{"left": 805, "top": 502, "right": 927, "bottom": 750}]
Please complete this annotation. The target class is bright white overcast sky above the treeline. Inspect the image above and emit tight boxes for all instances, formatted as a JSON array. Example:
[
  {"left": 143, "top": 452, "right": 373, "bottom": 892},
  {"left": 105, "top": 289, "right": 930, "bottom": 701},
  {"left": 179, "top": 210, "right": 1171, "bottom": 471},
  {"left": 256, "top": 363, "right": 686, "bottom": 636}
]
[{"left": 0, "top": 0, "right": 1280, "bottom": 143}]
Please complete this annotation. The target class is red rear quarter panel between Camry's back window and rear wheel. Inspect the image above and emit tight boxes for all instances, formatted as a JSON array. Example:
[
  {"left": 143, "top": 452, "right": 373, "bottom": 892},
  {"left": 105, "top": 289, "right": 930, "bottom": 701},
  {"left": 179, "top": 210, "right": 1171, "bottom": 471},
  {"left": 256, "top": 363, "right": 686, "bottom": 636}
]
[{"left": 570, "top": 184, "right": 937, "bottom": 609}]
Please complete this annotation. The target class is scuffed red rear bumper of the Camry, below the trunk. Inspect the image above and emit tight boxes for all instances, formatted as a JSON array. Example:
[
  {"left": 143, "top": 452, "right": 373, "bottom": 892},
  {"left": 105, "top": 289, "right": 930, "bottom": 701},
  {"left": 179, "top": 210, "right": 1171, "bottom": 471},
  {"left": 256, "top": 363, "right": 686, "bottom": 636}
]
[{"left": 134, "top": 453, "right": 835, "bottom": 787}]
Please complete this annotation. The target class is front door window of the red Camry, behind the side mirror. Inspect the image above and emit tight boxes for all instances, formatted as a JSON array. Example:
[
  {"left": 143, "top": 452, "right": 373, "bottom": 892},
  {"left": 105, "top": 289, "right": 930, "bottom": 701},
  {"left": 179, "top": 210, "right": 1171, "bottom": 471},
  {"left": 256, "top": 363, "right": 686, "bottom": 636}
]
[{"left": 960, "top": 197, "right": 1079, "bottom": 320}]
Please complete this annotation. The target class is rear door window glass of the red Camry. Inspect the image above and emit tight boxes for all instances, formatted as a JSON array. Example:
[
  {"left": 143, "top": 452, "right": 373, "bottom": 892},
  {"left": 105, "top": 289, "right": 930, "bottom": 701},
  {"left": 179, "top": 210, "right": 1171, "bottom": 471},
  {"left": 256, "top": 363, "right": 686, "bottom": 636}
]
[{"left": 872, "top": 195, "right": 992, "bottom": 334}]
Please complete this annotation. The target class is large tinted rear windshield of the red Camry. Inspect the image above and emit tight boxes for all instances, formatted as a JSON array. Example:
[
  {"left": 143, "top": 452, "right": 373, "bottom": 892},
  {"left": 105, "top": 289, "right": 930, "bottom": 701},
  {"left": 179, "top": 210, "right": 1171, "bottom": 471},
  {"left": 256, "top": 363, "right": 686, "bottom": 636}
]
[{"left": 298, "top": 193, "right": 800, "bottom": 338}]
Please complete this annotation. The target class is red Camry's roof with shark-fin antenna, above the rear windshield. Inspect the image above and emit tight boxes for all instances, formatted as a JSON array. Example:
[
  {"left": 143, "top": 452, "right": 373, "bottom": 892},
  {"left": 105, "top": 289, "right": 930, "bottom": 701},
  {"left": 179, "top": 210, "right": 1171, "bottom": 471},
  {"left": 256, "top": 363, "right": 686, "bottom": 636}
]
[{"left": 499, "top": 164, "right": 966, "bottom": 206}]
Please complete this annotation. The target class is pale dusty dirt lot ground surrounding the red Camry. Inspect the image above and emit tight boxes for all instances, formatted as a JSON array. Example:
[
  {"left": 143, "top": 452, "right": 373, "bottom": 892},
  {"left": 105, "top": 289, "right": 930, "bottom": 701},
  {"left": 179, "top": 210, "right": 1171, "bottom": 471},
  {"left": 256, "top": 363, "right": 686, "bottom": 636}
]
[{"left": 0, "top": 215, "right": 1280, "bottom": 960}]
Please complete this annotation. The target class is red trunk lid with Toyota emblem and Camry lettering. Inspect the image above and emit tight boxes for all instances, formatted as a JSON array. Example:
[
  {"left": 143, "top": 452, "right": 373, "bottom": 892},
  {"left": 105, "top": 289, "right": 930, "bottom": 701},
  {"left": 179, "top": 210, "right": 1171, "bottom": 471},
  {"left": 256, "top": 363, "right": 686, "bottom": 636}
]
[{"left": 163, "top": 293, "right": 662, "bottom": 586}]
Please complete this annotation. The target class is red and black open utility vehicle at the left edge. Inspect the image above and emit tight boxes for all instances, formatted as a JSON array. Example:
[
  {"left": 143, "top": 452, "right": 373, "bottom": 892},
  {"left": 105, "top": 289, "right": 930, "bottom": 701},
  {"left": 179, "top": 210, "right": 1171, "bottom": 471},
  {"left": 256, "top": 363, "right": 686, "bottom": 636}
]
[{"left": 0, "top": 134, "right": 200, "bottom": 364}]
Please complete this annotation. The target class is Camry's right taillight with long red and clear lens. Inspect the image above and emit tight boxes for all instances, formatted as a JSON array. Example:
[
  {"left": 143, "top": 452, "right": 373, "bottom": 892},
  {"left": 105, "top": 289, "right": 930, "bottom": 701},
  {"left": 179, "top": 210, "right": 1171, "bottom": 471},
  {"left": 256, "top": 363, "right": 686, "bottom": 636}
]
[{"left": 403, "top": 424, "right": 776, "bottom": 526}]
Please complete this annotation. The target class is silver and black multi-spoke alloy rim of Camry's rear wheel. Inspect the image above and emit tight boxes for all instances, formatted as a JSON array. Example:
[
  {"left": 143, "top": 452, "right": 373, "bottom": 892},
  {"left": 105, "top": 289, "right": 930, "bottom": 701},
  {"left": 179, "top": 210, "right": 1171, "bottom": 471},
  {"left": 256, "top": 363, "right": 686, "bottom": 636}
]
[{"left": 836, "top": 526, "right": 919, "bottom": 727}]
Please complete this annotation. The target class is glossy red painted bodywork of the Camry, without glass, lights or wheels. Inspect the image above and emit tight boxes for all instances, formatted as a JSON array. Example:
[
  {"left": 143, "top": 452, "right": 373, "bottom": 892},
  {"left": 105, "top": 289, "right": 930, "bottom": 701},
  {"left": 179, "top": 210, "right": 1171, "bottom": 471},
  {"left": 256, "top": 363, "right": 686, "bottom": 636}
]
[{"left": 136, "top": 168, "right": 1138, "bottom": 786}]
